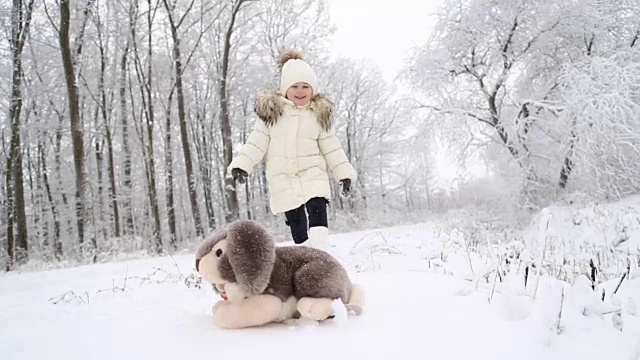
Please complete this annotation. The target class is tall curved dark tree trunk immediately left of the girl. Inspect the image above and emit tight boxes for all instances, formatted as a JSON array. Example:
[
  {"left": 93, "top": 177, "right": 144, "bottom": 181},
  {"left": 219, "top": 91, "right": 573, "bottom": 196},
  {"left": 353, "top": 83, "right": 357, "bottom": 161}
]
[{"left": 218, "top": 0, "right": 250, "bottom": 222}]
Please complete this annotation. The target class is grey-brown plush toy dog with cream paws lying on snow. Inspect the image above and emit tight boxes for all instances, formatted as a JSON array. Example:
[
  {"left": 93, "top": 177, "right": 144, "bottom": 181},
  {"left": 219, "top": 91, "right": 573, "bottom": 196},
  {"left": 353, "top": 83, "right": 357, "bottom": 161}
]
[{"left": 196, "top": 220, "right": 364, "bottom": 328}]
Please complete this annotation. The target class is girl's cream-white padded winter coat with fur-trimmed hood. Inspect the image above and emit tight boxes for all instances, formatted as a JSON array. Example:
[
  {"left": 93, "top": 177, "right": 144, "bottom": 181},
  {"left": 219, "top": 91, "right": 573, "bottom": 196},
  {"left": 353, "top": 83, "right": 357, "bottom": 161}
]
[{"left": 228, "top": 91, "right": 356, "bottom": 214}]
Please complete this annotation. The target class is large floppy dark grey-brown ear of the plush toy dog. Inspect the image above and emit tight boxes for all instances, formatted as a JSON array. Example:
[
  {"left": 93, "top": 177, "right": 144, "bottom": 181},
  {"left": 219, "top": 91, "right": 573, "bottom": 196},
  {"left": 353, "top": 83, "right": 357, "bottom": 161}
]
[{"left": 226, "top": 220, "right": 276, "bottom": 296}]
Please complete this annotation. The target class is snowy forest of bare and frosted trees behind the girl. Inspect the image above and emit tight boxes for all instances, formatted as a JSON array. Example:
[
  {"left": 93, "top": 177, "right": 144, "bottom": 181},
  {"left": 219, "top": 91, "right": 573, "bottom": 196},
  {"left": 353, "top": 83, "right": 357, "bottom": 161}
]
[{"left": 0, "top": 0, "right": 640, "bottom": 271}]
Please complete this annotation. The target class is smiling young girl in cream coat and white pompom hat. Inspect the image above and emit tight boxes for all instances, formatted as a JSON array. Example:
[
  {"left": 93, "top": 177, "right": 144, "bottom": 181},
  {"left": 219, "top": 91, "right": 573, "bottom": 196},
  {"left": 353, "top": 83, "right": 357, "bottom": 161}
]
[{"left": 229, "top": 51, "right": 356, "bottom": 249}]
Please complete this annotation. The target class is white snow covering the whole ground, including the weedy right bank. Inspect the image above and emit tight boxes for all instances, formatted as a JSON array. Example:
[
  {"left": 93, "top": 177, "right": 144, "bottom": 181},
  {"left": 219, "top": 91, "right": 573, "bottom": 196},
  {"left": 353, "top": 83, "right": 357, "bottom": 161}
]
[{"left": 0, "top": 204, "right": 640, "bottom": 360}]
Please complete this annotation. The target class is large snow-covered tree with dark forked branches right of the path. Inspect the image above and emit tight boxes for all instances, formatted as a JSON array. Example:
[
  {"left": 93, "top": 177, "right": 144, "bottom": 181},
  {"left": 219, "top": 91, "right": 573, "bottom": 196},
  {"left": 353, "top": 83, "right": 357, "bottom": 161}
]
[{"left": 405, "top": 0, "right": 638, "bottom": 208}]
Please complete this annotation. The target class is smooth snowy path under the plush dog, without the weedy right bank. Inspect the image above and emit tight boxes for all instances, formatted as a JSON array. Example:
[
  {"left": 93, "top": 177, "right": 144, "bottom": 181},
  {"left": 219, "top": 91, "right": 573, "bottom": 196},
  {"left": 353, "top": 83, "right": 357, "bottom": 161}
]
[{"left": 0, "top": 226, "right": 640, "bottom": 360}]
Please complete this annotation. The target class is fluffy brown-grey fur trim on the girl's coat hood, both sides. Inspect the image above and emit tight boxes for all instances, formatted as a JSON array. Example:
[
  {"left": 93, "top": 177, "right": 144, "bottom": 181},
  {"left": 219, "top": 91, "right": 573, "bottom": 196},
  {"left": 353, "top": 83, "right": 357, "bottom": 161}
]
[{"left": 254, "top": 90, "right": 334, "bottom": 131}]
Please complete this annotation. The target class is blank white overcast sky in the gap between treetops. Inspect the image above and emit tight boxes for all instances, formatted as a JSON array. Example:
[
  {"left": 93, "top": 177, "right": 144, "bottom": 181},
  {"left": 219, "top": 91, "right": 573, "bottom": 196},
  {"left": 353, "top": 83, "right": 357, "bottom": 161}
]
[{"left": 329, "top": 0, "right": 442, "bottom": 80}]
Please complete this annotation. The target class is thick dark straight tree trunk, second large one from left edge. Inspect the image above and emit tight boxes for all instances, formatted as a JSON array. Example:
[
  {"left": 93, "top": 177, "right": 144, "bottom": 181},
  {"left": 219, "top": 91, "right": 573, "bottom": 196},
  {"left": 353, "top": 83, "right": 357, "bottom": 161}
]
[{"left": 60, "top": 0, "right": 85, "bottom": 254}]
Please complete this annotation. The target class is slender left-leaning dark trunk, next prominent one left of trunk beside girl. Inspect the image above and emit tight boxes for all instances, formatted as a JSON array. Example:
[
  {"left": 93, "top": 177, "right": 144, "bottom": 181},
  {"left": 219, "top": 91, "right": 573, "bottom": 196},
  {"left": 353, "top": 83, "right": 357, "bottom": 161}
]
[{"left": 164, "top": 0, "right": 204, "bottom": 236}]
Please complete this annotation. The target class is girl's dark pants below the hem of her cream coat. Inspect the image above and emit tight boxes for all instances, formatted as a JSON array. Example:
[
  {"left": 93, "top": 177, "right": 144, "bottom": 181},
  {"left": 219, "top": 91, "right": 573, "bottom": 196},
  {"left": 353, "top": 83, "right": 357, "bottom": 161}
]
[{"left": 284, "top": 198, "right": 328, "bottom": 244}]
